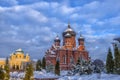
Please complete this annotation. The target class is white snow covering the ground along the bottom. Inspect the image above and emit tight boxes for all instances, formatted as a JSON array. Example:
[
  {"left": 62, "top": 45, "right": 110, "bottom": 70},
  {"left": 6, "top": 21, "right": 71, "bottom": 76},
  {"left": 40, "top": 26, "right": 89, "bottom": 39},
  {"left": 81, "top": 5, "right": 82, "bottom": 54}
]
[{"left": 10, "top": 70, "right": 120, "bottom": 80}]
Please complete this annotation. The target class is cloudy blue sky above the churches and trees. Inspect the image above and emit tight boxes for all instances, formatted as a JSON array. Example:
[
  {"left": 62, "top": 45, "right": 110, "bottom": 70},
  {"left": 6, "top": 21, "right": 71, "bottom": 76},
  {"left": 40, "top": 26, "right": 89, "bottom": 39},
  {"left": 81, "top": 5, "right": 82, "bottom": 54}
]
[{"left": 0, "top": 0, "right": 120, "bottom": 60}]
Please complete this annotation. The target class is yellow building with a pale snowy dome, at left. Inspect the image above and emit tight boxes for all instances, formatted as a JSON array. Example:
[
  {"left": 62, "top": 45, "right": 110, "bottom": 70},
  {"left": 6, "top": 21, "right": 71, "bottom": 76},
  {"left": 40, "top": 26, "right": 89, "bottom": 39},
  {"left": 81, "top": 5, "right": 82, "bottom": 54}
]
[{"left": 0, "top": 49, "right": 30, "bottom": 70}]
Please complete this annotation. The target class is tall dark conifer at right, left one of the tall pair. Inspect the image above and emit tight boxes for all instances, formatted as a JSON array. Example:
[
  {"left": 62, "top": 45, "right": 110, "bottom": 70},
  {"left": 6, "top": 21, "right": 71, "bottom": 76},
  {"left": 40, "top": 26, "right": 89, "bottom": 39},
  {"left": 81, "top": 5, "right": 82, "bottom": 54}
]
[{"left": 106, "top": 48, "right": 114, "bottom": 73}]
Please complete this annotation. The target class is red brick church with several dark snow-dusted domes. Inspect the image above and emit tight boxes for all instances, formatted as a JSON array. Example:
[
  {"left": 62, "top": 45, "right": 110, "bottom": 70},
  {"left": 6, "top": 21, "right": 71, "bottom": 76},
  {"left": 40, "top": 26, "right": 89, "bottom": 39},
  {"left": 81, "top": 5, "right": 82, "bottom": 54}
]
[{"left": 45, "top": 24, "right": 90, "bottom": 70}]
